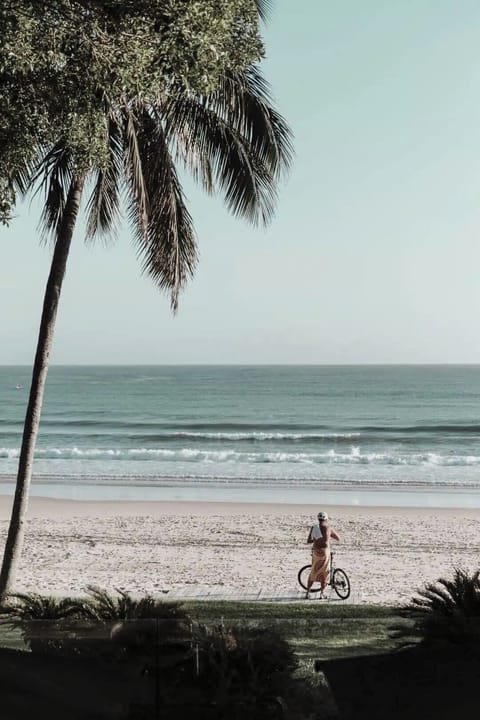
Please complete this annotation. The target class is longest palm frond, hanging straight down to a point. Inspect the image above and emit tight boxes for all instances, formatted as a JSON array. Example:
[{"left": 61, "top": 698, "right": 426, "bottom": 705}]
[{"left": 128, "top": 107, "right": 197, "bottom": 311}]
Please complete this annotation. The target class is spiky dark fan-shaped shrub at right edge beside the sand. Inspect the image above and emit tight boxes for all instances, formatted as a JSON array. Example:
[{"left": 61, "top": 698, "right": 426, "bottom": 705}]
[{"left": 406, "top": 569, "right": 480, "bottom": 654}]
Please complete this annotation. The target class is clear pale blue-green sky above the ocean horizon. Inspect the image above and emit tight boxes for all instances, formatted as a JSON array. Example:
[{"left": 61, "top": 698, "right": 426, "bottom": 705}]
[{"left": 0, "top": 0, "right": 480, "bottom": 364}]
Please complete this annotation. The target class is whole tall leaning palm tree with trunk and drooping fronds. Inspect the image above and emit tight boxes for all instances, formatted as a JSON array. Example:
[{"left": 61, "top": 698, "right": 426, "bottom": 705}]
[{"left": 0, "top": 66, "right": 292, "bottom": 597}]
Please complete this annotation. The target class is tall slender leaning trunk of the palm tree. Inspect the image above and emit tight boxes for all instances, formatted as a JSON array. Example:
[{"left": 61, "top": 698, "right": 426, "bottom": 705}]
[{"left": 0, "top": 176, "right": 84, "bottom": 599}]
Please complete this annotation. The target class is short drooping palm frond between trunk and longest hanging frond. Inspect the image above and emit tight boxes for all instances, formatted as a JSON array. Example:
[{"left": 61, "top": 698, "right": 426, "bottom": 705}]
[{"left": 87, "top": 112, "right": 124, "bottom": 239}]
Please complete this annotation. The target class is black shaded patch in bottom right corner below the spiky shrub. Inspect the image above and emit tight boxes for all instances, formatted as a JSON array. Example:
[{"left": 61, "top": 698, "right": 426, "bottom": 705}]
[{"left": 316, "top": 647, "right": 480, "bottom": 720}]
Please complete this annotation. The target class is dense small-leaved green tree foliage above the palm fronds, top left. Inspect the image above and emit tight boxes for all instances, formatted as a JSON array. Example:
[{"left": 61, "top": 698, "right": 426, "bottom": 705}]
[{"left": 0, "top": 0, "right": 268, "bottom": 222}]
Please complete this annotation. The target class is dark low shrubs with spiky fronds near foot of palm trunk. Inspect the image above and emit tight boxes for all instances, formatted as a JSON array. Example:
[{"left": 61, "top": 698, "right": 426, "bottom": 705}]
[{"left": 2, "top": 587, "right": 324, "bottom": 720}]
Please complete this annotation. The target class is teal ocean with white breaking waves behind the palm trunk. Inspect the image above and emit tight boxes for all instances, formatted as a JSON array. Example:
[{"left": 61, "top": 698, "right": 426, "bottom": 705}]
[{"left": 0, "top": 365, "right": 480, "bottom": 507}]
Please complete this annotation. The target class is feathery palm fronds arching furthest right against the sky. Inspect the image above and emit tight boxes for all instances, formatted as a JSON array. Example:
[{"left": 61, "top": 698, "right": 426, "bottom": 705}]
[{"left": 164, "top": 67, "right": 293, "bottom": 225}]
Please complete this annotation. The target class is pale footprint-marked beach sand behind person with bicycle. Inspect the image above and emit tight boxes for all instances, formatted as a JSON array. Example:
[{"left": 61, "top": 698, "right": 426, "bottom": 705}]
[{"left": 0, "top": 497, "right": 480, "bottom": 604}]
